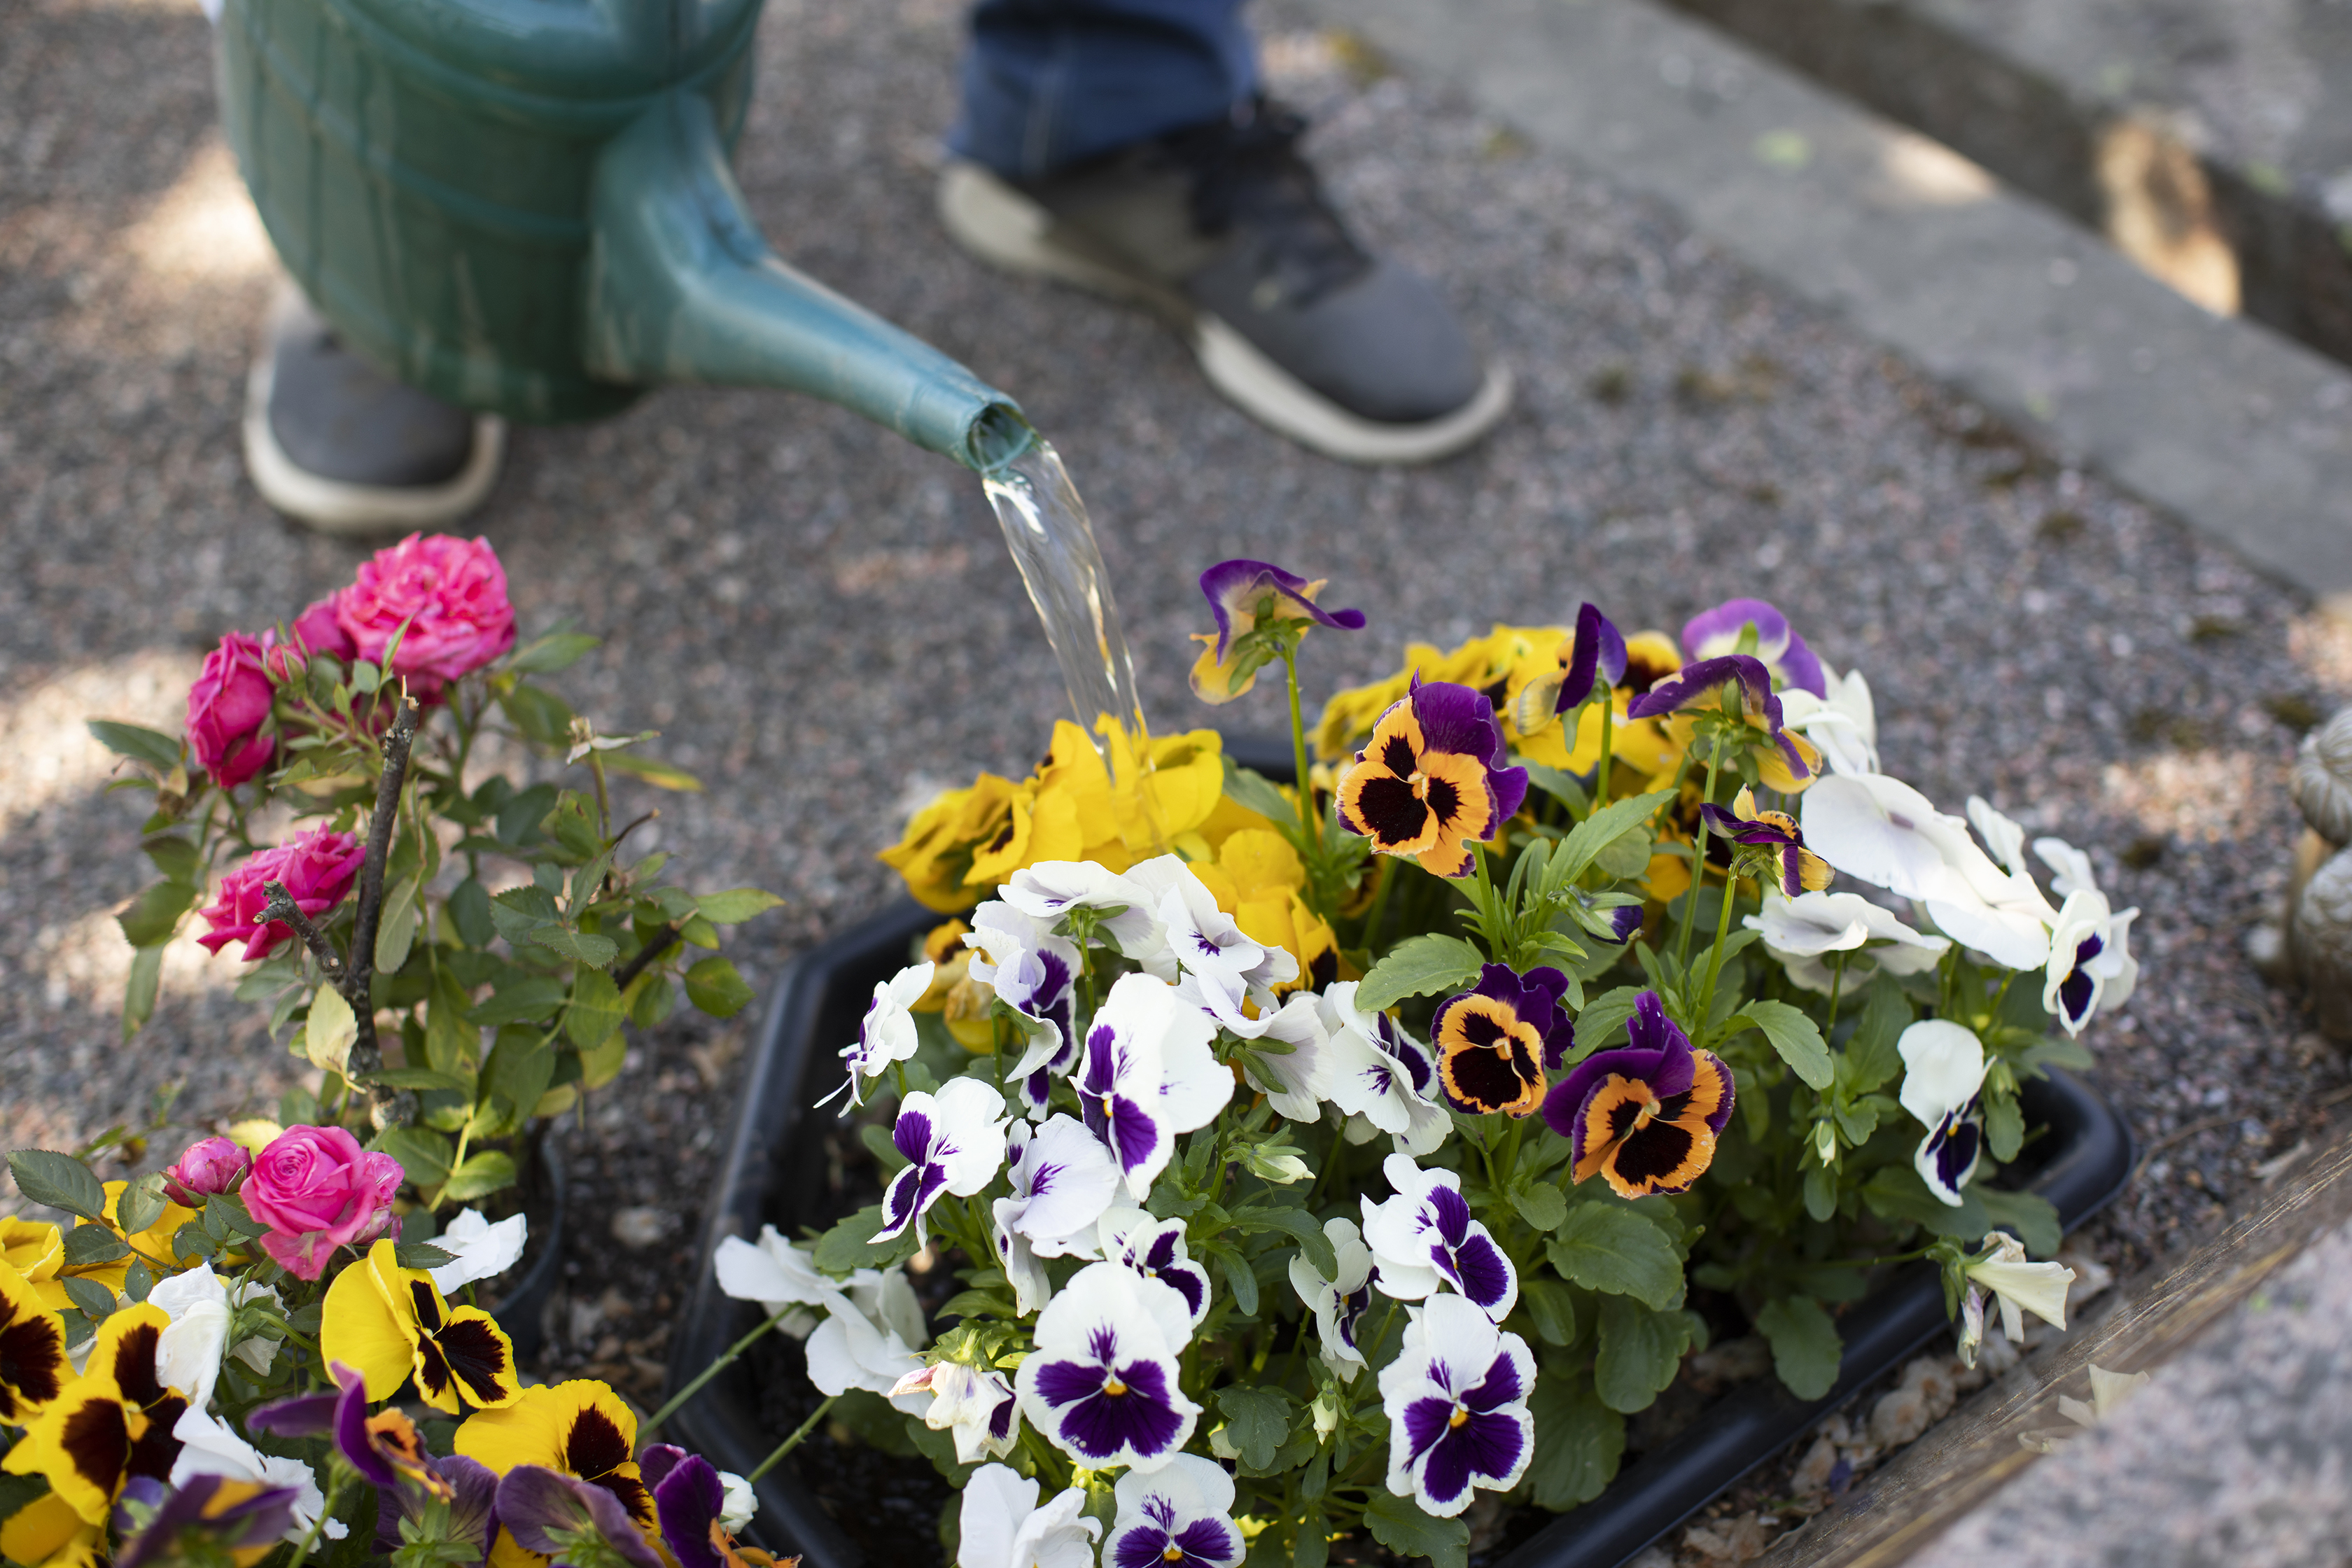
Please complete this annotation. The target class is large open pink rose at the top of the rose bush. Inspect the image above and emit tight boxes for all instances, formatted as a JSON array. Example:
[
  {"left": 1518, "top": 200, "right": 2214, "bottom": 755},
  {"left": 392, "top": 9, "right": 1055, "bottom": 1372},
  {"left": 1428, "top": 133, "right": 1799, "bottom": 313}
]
[{"left": 334, "top": 533, "right": 515, "bottom": 696}]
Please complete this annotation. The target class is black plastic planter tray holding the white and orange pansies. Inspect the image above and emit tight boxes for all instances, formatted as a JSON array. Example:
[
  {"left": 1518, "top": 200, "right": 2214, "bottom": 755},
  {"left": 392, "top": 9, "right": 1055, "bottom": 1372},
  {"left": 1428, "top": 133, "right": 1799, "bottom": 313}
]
[{"left": 671, "top": 746, "right": 2134, "bottom": 1568}]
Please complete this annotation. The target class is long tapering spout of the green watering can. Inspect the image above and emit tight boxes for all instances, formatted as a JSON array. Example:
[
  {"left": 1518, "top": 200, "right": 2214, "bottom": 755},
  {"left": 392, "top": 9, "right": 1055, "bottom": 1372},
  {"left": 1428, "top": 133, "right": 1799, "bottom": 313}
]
[{"left": 583, "top": 92, "right": 1035, "bottom": 472}]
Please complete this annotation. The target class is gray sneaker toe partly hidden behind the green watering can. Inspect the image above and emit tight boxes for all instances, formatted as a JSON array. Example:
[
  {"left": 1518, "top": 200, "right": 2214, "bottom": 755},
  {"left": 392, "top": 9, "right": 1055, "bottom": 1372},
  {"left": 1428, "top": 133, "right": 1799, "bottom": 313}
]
[{"left": 244, "top": 287, "right": 505, "bottom": 533}]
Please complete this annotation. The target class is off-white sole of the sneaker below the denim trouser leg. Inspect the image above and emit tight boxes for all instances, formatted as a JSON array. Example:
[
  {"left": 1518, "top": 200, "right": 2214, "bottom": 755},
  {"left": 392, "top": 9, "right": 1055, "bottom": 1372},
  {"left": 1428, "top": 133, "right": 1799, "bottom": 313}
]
[{"left": 939, "top": 160, "right": 1512, "bottom": 463}]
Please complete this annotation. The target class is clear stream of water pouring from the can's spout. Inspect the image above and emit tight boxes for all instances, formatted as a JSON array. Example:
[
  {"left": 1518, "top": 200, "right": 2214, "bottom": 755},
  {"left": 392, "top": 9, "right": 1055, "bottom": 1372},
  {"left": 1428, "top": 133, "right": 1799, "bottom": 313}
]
[{"left": 981, "top": 435, "right": 1167, "bottom": 848}]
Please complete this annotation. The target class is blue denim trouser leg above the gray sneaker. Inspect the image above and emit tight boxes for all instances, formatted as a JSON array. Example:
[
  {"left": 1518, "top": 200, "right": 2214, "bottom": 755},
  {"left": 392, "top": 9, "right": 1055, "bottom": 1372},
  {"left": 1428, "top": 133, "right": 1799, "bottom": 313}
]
[{"left": 950, "top": 0, "right": 1259, "bottom": 178}]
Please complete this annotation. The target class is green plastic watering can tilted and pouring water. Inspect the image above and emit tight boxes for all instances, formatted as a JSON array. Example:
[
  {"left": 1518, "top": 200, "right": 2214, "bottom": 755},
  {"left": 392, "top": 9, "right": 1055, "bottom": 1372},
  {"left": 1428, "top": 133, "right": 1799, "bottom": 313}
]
[{"left": 218, "top": 0, "right": 1032, "bottom": 472}]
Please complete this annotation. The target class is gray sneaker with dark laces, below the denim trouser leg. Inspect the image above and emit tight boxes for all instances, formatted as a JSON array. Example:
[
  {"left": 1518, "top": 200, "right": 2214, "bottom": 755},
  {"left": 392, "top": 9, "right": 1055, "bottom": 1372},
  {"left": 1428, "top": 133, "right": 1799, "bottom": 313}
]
[{"left": 939, "top": 101, "right": 1510, "bottom": 463}]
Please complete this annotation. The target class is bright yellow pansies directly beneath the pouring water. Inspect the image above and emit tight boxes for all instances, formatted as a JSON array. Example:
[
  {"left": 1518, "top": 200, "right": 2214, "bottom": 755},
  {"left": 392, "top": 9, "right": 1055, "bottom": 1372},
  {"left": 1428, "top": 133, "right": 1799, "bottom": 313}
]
[{"left": 882, "top": 717, "right": 1263, "bottom": 914}]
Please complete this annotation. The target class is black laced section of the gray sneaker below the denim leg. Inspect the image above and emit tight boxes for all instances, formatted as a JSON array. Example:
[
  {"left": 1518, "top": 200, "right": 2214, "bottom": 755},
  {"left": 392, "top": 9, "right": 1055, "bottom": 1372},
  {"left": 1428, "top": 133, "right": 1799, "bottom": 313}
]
[{"left": 1162, "top": 99, "right": 1371, "bottom": 306}]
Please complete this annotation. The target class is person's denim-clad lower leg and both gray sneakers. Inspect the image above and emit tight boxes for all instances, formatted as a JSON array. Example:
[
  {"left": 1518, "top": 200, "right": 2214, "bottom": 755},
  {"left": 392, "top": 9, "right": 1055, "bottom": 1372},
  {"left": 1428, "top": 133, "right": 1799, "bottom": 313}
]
[{"left": 244, "top": 0, "right": 1510, "bottom": 531}]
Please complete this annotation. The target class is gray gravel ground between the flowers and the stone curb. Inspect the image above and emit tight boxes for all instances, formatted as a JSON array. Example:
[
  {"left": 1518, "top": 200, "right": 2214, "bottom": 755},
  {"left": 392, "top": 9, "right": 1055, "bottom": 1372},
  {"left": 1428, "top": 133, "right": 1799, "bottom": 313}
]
[{"left": 0, "top": 0, "right": 2352, "bottom": 1485}]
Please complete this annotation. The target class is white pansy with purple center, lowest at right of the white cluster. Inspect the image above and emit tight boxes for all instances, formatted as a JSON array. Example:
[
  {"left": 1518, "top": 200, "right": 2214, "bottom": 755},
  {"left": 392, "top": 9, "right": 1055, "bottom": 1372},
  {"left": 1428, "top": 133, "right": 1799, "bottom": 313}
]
[{"left": 1380, "top": 1295, "right": 1536, "bottom": 1518}]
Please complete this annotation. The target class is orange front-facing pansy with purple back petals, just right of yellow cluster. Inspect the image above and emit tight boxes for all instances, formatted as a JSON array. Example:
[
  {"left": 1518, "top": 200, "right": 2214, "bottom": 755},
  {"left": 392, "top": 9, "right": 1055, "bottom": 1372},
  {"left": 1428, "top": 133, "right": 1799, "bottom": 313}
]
[{"left": 1338, "top": 675, "right": 1527, "bottom": 877}]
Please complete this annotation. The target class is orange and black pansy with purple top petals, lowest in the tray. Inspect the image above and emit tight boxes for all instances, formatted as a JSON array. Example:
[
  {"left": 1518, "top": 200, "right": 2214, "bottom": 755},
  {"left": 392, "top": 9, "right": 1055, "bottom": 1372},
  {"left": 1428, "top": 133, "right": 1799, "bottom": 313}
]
[{"left": 1543, "top": 992, "right": 1731, "bottom": 1199}]
